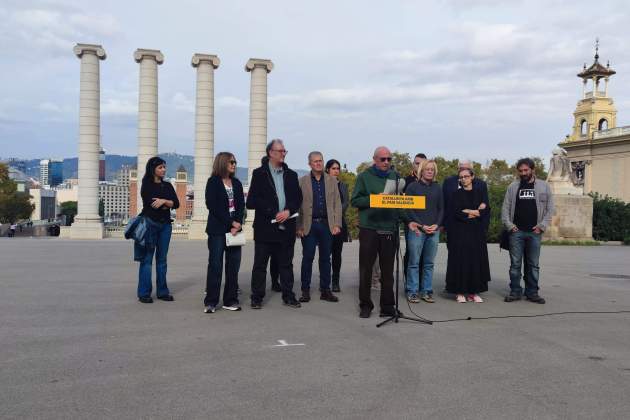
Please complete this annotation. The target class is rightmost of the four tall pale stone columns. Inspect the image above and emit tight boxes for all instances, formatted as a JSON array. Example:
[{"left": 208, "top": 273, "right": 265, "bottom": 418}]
[{"left": 245, "top": 58, "right": 273, "bottom": 183}]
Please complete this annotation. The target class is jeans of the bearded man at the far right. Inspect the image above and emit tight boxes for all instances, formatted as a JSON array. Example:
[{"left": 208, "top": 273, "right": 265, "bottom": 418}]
[{"left": 510, "top": 230, "right": 542, "bottom": 296}]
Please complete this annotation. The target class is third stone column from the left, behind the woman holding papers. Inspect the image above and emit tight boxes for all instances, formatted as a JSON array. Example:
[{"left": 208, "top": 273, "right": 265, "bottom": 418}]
[{"left": 188, "top": 54, "right": 221, "bottom": 239}]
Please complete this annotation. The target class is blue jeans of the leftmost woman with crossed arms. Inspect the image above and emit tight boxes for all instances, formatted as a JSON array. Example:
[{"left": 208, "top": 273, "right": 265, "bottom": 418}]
[{"left": 138, "top": 223, "right": 173, "bottom": 297}]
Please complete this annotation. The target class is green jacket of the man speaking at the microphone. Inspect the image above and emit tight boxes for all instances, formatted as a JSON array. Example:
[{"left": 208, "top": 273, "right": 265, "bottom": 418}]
[{"left": 351, "top": 167, "right": 399, "bottom": 232}]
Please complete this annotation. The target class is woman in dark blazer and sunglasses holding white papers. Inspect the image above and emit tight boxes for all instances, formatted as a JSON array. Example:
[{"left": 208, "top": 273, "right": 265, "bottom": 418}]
[{"left": 203, "top": 152, "right": 245, "bottom": 314}]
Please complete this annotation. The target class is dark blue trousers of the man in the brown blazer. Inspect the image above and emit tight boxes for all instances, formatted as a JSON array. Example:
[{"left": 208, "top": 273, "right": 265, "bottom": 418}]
[{"left": 301, "top": 222, "right": 333, "bottom": 291}]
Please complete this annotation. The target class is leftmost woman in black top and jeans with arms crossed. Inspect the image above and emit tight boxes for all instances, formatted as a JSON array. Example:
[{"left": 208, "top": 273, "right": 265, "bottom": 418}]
[{"left": 138, "top": 156, "right": 179, "bottom": 303}]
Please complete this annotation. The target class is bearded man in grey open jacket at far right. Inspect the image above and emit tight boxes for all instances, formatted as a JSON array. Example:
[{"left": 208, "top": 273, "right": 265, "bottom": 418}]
[{"left": 501, "top": 158, "right": 553, "bottom": 304}]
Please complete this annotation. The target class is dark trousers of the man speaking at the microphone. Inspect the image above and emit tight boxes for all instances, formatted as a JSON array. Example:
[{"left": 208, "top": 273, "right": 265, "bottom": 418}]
[{"left": 359, "top": 229, "right": 395, "bottom": 311}]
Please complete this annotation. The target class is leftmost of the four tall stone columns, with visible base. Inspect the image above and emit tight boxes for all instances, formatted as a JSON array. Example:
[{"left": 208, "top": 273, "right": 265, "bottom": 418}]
[{"left": 69, "top": 44, "right": 106, "bottom": 239}]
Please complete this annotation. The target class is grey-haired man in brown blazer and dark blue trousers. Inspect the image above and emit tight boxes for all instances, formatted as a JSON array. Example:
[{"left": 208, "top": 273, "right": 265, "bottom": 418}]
[{"left": 297, "top": 152, "right": 342, "bottom": 302}]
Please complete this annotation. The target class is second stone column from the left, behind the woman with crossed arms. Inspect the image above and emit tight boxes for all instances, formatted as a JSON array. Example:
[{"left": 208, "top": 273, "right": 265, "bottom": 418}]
[{"left": 133, "top": 48, "right": 164, "bottom": 216}]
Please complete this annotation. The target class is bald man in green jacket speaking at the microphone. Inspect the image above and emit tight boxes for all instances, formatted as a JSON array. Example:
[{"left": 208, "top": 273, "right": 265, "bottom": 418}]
[{"left": 351, "top": 147, "right": 402, "bottom": 318}]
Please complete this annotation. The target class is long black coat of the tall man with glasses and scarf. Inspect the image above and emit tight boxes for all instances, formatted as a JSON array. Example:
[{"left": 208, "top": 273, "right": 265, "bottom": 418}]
[{"left": 247, "top": 159, "right": 302, "bottom": 242}]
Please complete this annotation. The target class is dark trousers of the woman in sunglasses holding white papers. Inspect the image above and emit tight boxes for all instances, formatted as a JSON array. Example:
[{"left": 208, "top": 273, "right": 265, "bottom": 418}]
[{"left": 203, "top": 235, "right": 241, "bottom": 306}]
